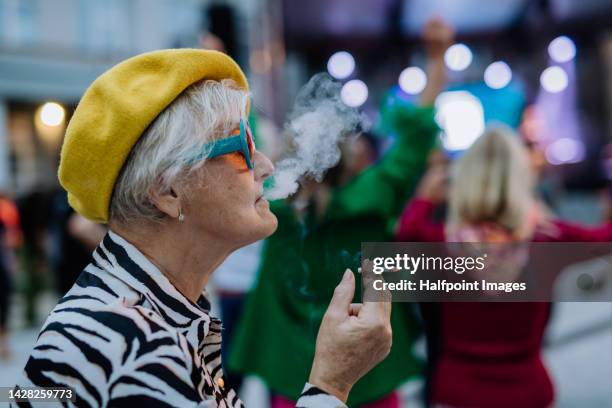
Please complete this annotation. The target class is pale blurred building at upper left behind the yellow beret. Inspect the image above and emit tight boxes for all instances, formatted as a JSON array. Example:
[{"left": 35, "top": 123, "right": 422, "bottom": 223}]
[{"left": 0, "top": 0, "right": 256, "bottom": 195}]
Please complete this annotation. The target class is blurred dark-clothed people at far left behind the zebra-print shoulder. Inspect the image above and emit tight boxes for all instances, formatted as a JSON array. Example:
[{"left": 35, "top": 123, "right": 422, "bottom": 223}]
[{"left": 0, "top": 191, "right": 106, "bottom": 360}]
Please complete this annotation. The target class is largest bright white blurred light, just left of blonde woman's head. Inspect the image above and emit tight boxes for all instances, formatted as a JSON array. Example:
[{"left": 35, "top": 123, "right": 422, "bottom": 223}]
[{"left": 436, "top": 91, "right": 485, "bottom": 151}]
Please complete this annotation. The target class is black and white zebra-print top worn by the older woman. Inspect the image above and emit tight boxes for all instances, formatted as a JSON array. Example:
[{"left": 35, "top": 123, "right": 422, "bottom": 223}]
[{"left": 17, "top": 232, "right": 344, "bottom": 407}]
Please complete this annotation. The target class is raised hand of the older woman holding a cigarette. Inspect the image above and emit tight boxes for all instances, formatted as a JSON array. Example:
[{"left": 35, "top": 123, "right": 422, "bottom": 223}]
[{"left": 309, "top": 269, "right": 391, "bottom": 402}]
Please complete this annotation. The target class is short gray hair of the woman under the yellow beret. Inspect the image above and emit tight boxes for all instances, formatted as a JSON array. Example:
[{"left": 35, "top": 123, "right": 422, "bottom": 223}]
[{"left": 110, "top": 80, "right": 249, "bottom": 224}]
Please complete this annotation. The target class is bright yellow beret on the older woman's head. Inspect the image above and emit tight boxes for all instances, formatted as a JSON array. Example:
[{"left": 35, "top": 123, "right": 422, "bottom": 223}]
[{"left": 58, "top": 49, "right": 248, "bottom": 223}]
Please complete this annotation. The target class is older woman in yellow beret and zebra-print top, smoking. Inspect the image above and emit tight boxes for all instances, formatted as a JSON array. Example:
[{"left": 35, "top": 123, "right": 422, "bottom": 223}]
[{"left": 15, "top": 49, "right": 391, "bottom": 407}]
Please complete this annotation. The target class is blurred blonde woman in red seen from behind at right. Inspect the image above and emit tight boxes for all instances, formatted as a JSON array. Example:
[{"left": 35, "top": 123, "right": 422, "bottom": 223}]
[{"left": 397, "top": 128, "right": 612, "bottom": 408}]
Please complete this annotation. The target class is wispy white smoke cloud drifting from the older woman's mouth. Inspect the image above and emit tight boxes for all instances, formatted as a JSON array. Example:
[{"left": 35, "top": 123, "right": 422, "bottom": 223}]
[{"left": 265, "top": 74, "right": 367, "bottom": 200}]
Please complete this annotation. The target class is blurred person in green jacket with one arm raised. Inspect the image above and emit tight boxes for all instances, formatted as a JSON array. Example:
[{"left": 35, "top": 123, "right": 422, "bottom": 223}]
[{"left": 229, "top": 20, "right": 453, "bottom": 406}]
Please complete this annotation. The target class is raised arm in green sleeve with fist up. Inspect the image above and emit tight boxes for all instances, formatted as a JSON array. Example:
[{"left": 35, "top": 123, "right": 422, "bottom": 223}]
[{"left": 335, "top": 19, "right": 454, "bottom": 222}]
